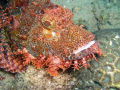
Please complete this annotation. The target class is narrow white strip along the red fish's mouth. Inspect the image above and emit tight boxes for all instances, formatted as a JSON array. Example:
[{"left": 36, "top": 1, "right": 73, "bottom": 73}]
[{"left": 73, "top": 40, "right": 96, "bottom": 54}]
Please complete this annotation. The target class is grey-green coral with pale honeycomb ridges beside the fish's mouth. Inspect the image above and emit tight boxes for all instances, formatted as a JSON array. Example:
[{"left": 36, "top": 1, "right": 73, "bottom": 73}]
[{"left": 71, "top": 29, "right": 120, "bottom": 90}]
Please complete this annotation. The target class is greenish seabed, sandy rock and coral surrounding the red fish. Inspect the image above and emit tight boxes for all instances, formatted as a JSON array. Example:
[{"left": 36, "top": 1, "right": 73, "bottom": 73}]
[{"left": 0, "top": 0, "right": 120, "bottom": 90}]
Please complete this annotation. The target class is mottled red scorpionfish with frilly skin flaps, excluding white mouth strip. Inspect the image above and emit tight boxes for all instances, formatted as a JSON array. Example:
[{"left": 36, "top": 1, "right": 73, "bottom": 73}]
[{"left": 0, "top": 0, "right": 104, "bottom": 76}]
